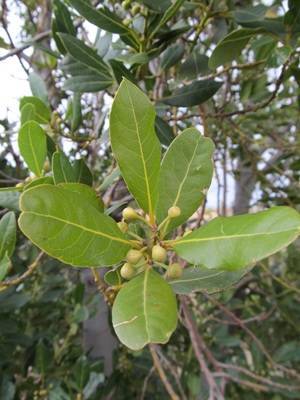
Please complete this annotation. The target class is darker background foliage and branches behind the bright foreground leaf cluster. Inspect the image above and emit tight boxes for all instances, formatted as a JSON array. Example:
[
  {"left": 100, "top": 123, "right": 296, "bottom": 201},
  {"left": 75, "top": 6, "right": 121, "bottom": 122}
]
[{"left": 0, "top": 0, "right": 300, "bottom": 400}]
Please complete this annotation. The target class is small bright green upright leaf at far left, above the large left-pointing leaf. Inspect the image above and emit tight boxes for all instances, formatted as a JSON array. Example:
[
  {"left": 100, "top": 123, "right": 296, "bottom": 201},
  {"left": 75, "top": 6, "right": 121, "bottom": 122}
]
[{"left": 18, "top": 121, "right": 47, "bottom": 176}]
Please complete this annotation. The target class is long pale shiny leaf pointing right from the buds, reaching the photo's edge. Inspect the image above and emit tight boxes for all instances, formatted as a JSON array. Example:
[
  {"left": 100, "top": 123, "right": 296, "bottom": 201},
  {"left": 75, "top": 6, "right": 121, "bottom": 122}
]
[{"left": 174, "top": 207, "right": 300, "bottom": 270}]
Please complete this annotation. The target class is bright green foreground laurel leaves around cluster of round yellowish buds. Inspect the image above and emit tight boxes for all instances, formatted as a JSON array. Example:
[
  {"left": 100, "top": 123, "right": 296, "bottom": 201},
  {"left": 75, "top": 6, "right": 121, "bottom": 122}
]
[{"left": 0, "top": 79, "right": 300, "bottom": 350}]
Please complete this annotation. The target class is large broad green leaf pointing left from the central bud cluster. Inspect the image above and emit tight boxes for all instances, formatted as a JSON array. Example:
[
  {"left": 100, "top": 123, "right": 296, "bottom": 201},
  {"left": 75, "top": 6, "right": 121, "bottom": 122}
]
[{"left": 19, "top": 185, "right": 131, "bottom": 267}]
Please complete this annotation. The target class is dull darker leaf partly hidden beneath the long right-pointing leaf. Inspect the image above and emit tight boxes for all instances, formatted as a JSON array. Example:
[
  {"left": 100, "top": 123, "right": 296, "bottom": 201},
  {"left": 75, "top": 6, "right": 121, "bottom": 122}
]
[{"left": 169, "top": 267, "right": 248, "bottom": 294}]
